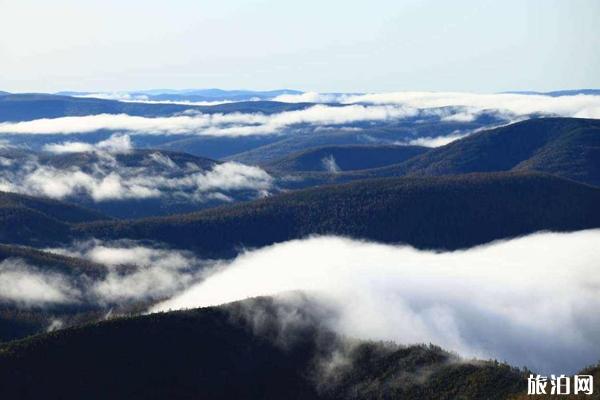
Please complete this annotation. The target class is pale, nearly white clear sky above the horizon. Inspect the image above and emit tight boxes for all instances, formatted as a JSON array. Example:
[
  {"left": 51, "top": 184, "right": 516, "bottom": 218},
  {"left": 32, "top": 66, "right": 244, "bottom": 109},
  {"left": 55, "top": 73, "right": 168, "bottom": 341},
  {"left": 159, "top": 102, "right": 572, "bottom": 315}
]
[{"left": 0, "top": 0, "right": 600, "bottom": 93}]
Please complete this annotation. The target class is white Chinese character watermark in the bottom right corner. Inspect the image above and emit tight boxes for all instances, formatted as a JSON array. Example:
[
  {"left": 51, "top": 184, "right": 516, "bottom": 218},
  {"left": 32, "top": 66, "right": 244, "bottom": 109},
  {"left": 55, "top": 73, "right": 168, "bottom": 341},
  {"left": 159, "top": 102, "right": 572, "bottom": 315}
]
[{"left": 527, "top": 374, "right": 594, "bottom": 395}]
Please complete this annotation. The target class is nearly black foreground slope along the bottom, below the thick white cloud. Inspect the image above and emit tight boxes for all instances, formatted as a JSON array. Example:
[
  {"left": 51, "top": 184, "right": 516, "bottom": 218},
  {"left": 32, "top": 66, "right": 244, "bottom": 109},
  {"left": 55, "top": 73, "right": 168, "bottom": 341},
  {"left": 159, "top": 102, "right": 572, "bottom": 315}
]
[{"left": 0, "top": 298, "right": 526, "bottom": 400}]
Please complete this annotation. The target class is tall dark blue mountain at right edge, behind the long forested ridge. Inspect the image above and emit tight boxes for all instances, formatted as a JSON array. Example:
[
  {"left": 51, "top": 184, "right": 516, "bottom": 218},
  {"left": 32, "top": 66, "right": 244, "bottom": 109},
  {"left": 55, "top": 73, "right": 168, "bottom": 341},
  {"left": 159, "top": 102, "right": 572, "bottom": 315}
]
[{"left": 376, "top": 118, "right": 600, "bottom": 185}]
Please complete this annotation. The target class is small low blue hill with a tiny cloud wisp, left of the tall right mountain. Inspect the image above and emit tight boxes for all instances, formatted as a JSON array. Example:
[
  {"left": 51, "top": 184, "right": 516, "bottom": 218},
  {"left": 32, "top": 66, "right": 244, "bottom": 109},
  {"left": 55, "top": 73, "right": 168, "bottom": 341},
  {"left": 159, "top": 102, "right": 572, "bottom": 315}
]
[{"left": 263, "top": 145, "right": 429, "bottom": 172}]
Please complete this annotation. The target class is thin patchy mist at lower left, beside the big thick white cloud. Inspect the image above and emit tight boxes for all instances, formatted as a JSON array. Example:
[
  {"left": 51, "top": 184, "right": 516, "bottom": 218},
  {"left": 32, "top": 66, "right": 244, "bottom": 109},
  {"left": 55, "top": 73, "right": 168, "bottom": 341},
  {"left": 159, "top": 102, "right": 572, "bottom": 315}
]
[{"left": 0, "top": 240, "right": 212, "bottom": 307}]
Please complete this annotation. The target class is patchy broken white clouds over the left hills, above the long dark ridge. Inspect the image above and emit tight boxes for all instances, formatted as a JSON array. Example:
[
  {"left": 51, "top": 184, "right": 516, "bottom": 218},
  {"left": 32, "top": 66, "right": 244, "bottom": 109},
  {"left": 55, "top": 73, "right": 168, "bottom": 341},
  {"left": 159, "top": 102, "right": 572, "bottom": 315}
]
[{"left": 0, "top": 135, "right": 273, "bottom": 202}]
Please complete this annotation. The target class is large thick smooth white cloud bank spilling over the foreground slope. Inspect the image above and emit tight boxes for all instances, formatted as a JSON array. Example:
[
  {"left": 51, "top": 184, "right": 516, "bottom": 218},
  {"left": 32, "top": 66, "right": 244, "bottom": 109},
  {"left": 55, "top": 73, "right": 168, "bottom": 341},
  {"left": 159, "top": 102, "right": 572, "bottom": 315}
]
[{"left": 153, "top": 230, "right": 600, "bottom": 373}]
